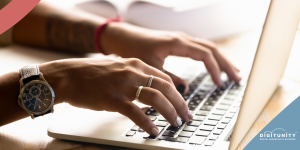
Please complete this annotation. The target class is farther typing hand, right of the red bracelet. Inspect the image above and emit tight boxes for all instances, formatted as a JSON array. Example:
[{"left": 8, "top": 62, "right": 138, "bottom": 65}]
[{"left": 101, "top": 23, "right": 240, "bottom": 91}]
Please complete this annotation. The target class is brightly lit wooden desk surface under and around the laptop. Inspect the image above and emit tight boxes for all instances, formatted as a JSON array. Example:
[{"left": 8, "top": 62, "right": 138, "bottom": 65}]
[{"left": 0, "top": 29, "right": 300, "bottom": 150}]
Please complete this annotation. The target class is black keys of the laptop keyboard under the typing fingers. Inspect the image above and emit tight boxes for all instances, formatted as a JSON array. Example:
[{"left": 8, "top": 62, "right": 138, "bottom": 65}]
[{"left": 126, "top": 74, "right": 245, "bottom": 146}]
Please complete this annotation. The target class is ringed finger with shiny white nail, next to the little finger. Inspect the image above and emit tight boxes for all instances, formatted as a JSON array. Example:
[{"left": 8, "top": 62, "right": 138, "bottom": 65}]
[{"left": 139, "top": 87, "right": 182, "bottom": 127}]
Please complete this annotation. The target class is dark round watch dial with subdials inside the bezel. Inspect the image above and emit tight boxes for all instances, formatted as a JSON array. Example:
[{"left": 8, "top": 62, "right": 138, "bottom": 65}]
[{"left": 22, "top": 82, "right": 53, "bottom": 112}]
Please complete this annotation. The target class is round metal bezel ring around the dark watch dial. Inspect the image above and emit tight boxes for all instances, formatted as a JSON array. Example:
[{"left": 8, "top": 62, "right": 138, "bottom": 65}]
[{"left": 18, "top": 80, "right": 55, "bottom": 115}]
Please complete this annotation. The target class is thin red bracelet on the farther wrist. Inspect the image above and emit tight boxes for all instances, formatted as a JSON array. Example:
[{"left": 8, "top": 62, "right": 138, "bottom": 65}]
[{"left": 95, "top": 17, "right": 121, "bottom": 55}]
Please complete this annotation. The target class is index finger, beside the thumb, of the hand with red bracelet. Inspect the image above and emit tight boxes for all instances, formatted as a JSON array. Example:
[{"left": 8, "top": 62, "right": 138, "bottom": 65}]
[{"left": 187, "top": 41, "right": 223, "bottom": 86}]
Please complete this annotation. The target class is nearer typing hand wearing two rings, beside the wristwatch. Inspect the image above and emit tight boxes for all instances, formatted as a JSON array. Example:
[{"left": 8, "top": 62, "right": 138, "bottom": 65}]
[{"left": 40, "top": 58, "right": 192, "bottom": 135}]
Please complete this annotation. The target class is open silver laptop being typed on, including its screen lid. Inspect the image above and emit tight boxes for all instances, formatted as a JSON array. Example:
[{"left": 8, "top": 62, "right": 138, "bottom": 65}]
[{"left": 48, "top": 0, "right": 300, "bottom": 150}]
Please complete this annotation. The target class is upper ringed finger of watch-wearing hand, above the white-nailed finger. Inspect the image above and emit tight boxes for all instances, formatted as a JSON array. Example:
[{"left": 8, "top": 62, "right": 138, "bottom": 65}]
[{"left": 146, "top": 77, "right": 193, "bottom": 122}]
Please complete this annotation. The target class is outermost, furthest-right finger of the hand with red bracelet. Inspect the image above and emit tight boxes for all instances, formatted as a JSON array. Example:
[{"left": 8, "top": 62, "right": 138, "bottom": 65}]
[{"left": 189, "top": 38, "right": 240, "bottom": 82}]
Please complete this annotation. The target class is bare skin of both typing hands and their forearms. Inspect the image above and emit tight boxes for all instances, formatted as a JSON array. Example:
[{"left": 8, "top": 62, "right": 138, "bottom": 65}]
[{"left": 0, "top": 2, "right": 240, "bottom": 134}]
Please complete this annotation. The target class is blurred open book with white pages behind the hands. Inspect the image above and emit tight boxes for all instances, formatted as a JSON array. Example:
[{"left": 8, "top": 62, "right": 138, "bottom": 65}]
[{"left": 76, "top": 0, "right": 270, "bottom": 40}]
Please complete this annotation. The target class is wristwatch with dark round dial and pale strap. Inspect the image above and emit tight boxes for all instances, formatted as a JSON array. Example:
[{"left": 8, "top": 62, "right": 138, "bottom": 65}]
[{"left": 18, "top": 64, "right": 55, "bottom": 119}]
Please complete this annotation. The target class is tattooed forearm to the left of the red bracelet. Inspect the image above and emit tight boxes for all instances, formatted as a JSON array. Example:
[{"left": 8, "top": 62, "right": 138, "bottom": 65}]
[{"left": 13, "top": 2, "right": 105, "bottom": 53}]
